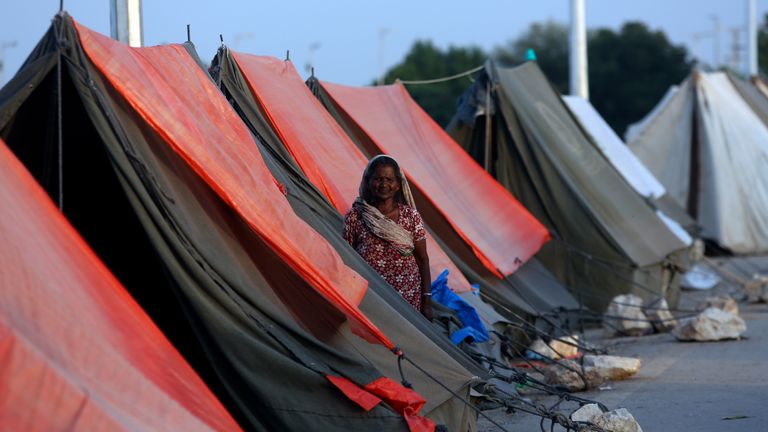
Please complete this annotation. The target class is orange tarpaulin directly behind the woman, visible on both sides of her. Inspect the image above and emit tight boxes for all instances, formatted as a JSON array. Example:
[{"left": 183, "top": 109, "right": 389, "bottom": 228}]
[{"left": 230, "top": 51, "right": 471, "bottom": 292}]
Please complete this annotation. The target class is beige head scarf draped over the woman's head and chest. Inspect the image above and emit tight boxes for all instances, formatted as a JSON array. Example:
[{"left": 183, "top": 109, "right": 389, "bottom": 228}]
[{"left": 352, "top": 155, "right": 416, "bottom": 255}]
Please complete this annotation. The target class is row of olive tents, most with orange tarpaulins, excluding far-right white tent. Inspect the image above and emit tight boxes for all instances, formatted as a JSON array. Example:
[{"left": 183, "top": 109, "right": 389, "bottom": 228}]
[{"left": 0, "top": 13, "right": 756, "bottom": 430}]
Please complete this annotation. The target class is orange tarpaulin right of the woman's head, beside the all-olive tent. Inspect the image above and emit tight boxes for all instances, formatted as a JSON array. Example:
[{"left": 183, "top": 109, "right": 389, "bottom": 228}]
[{"left": 322, "top": 82, "right": 549, "bottom": 276}]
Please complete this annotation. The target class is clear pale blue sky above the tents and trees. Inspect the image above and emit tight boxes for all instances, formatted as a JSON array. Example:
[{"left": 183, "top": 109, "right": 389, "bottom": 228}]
[{"left": 0, "top": 0, "right": 768, "bottom": 85}]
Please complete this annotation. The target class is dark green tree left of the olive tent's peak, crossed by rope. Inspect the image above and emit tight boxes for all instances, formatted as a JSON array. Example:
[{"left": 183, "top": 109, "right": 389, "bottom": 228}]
[{"left": 384, "top": 41, "right": 487, "bottom": 127}]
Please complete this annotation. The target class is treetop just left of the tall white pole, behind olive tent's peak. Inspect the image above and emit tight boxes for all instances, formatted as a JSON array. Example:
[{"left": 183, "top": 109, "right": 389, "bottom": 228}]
[{"left": 493, "top": 21, "right": 568, "bottom": 94}]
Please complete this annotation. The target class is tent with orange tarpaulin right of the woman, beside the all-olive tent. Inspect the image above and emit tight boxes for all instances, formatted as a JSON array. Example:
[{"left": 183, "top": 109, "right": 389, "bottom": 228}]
[{"left": 309, "top": 73, "right": 578, "bottom": 316}]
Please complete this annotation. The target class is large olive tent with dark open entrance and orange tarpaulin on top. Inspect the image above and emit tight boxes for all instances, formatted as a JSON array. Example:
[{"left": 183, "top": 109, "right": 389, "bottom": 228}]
[{"left": 0, "top": 14, "right": 472, "bottom": 430}]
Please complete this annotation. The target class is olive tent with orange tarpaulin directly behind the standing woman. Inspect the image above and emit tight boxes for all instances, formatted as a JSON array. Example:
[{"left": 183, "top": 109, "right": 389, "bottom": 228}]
[{"left": 212, "top": 49, "right": 520, "bottom": 374}]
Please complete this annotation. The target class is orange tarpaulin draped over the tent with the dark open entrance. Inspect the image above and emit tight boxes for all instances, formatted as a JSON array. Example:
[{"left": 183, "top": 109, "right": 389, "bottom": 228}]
[{"left": 75, "top": 23, "right": 393, "bottom": 349}]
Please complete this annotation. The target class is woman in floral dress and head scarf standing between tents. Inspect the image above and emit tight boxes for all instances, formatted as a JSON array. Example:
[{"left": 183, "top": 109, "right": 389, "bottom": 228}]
[{"left": 344, "top": 155, "right": 432, "bottom": 320}]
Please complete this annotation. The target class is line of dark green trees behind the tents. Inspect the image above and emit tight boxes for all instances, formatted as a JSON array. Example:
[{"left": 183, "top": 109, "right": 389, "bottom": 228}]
[{"left": 384, "top": 14, "right": 768, "bottom": 135}]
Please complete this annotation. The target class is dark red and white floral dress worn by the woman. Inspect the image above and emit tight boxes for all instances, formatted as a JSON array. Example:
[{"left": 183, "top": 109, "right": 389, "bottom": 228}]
[{"left": 344, "top": 204, "right": 427, "bottom": 311}]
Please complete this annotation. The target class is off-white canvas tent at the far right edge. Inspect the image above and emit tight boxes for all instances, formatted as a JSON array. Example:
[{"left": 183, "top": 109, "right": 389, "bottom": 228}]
[{"left": 627, "top": 72, "right": 768, "bottom": 254}]
